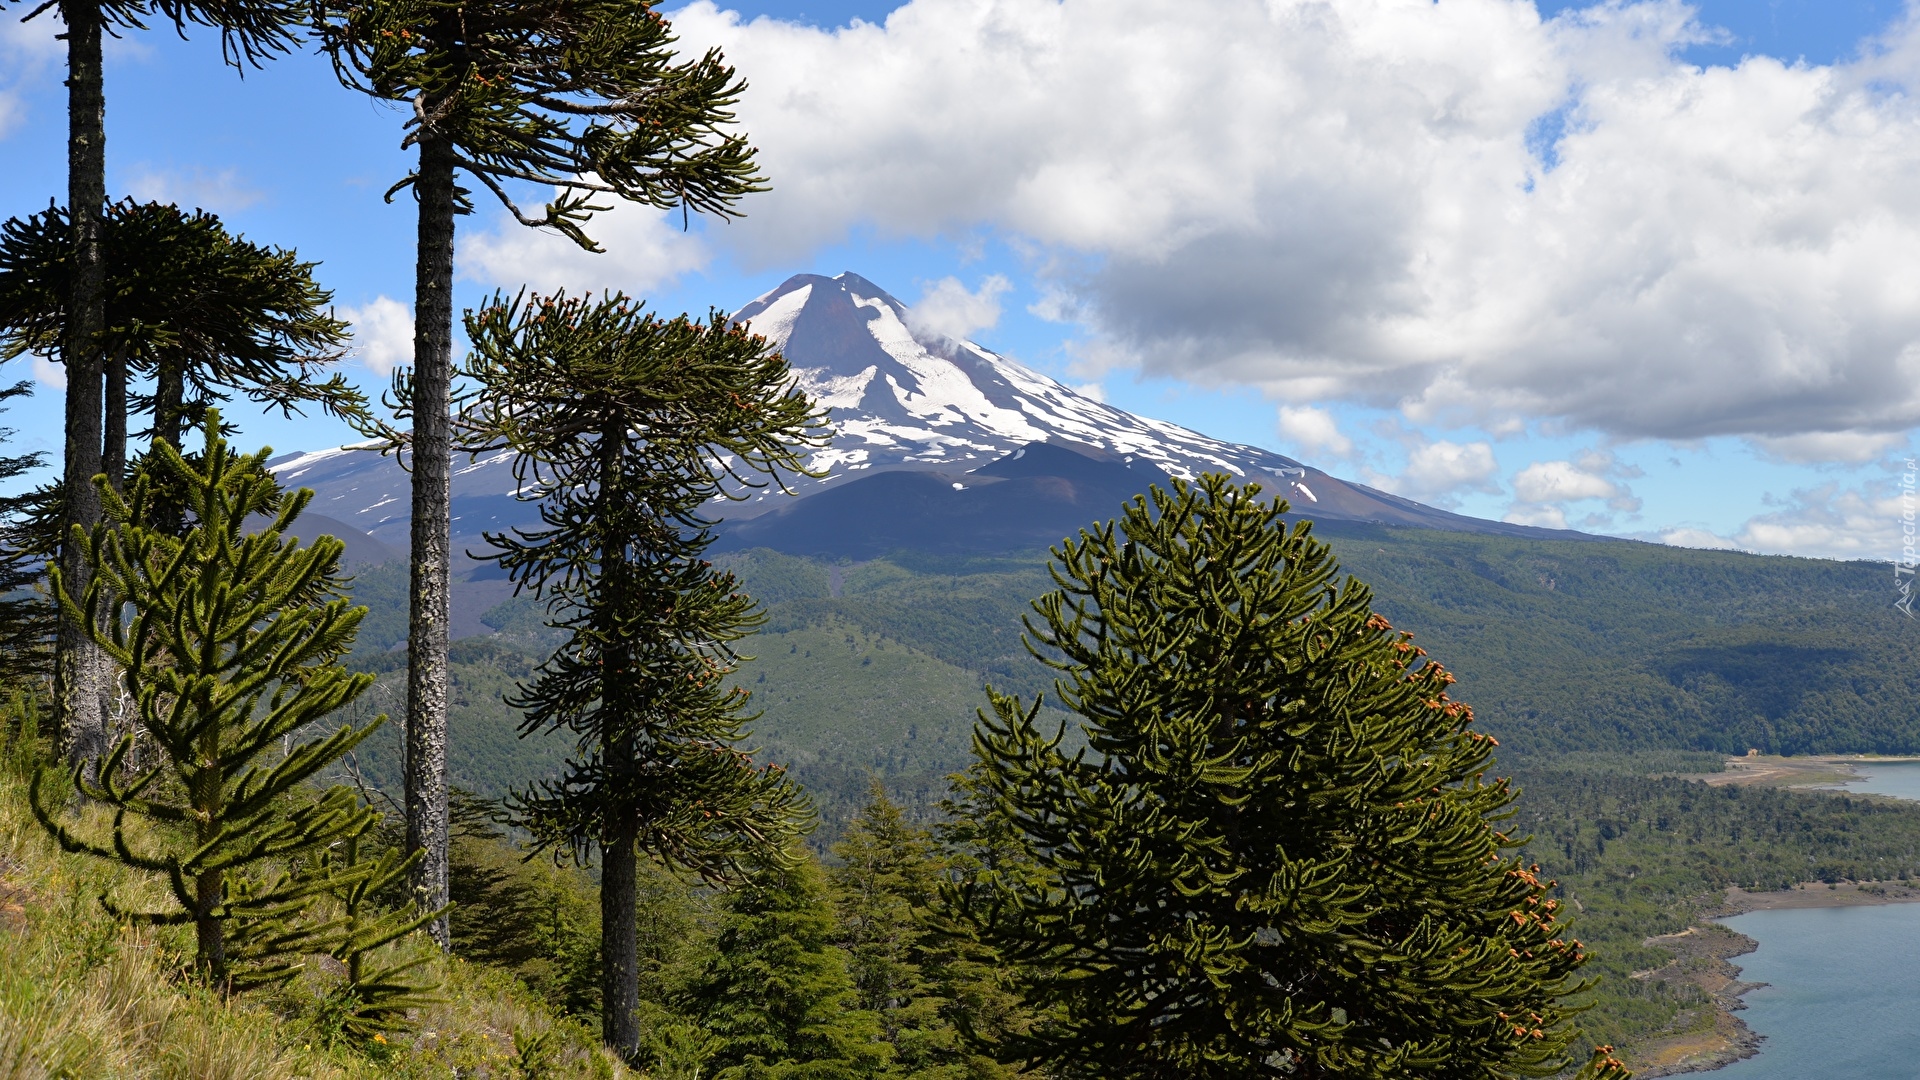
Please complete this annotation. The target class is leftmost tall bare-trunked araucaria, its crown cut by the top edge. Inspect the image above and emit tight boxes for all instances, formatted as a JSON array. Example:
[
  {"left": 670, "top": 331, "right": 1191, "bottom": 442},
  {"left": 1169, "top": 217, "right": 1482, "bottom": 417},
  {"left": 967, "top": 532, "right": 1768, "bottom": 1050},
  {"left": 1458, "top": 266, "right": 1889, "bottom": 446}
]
[{"left": 0, "top": 0, "right": 303, "bottom": 759}]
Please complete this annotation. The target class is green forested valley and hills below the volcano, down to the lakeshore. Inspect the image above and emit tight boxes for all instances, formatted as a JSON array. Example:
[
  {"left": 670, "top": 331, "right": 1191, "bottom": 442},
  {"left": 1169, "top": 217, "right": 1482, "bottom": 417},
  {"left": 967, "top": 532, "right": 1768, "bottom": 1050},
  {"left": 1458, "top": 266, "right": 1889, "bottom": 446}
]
[{"left": 314, "top": 523, "right": 1920, "bottom": 1074}]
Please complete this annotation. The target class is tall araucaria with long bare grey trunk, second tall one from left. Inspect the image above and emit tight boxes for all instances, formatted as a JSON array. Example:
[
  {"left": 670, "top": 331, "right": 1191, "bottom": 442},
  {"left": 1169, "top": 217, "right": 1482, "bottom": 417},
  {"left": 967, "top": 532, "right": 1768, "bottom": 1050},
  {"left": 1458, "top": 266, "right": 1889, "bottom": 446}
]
[{"left": 315, "top": 0, "right": 758, "bottom": 944}]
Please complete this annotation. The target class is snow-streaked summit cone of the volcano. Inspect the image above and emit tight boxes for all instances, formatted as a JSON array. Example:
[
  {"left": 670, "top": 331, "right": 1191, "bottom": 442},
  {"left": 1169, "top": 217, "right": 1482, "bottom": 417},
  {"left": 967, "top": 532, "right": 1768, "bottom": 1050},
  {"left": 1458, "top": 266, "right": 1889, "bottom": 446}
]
[{"left": 733, "top": 273, "right": 1300, "bottom": 482}]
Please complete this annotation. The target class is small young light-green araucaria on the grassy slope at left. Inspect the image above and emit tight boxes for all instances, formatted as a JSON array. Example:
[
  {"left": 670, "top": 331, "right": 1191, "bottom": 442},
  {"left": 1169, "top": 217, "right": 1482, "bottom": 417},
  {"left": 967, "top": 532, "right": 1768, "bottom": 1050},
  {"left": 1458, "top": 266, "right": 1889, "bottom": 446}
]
[{"left": 33, "top": 411, "right": 384, "bottom": 986}]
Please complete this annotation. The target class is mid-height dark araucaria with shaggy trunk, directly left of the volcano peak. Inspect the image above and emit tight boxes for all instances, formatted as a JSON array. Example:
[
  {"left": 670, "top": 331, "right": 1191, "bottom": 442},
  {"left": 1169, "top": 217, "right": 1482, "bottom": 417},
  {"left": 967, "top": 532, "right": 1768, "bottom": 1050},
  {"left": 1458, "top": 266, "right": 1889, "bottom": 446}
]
[{"left": 463, "top": 288, "right": 822, "bottom": 1057}]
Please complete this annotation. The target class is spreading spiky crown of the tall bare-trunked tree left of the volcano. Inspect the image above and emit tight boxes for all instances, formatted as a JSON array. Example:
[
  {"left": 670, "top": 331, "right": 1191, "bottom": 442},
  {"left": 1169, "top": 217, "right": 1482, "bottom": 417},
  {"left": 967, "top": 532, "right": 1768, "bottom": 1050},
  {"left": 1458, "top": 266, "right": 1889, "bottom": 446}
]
[{"left": 315, "top": 0, "right": 760, "bottom": 250}]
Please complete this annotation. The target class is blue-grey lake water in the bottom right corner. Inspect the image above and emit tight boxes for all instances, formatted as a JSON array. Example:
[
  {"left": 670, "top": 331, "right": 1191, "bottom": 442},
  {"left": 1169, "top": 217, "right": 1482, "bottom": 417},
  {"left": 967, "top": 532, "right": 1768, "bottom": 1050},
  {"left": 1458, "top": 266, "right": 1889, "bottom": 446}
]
[{"left": 1711, "top": 903, "right": 1920, "bottom": 1080}]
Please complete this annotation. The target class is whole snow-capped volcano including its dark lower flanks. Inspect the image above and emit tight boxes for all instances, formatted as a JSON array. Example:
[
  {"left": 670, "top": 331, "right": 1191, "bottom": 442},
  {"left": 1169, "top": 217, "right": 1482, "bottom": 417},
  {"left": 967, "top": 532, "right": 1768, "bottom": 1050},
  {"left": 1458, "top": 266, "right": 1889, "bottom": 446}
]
[{"left": 273, "top": 273, "right": 1582, "bottom": 572}]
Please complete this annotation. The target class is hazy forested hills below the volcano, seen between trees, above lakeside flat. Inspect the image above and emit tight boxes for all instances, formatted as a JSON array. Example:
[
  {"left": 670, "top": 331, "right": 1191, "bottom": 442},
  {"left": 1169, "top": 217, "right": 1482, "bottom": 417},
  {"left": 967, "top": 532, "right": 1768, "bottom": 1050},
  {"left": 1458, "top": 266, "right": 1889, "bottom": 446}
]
[{"left": 341, "top": 523, "right": 1920, "bottom": 822}]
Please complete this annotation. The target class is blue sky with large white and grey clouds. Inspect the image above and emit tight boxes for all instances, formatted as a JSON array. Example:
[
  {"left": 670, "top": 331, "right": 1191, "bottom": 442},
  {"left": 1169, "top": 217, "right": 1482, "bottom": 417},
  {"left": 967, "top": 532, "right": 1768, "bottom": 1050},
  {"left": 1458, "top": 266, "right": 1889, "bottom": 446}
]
[{"left": 0, "top": 0, "right": 1920, "bottom": 559}]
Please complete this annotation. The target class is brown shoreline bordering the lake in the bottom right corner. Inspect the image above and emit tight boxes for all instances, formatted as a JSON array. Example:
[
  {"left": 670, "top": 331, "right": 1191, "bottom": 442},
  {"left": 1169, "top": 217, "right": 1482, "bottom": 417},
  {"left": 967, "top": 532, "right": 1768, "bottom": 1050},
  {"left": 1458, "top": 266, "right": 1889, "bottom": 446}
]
[{"left": 1630, "top": 882, "right": 1920, "bottom": 1078}]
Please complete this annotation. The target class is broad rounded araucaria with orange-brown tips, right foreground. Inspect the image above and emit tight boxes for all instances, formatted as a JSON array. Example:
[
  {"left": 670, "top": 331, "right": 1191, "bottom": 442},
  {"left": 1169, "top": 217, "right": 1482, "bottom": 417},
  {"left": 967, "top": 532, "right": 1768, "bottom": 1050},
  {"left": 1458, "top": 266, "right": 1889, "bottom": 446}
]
[{"left": 945, "top": 475, "right": 1584, "bottom": 1080}]
